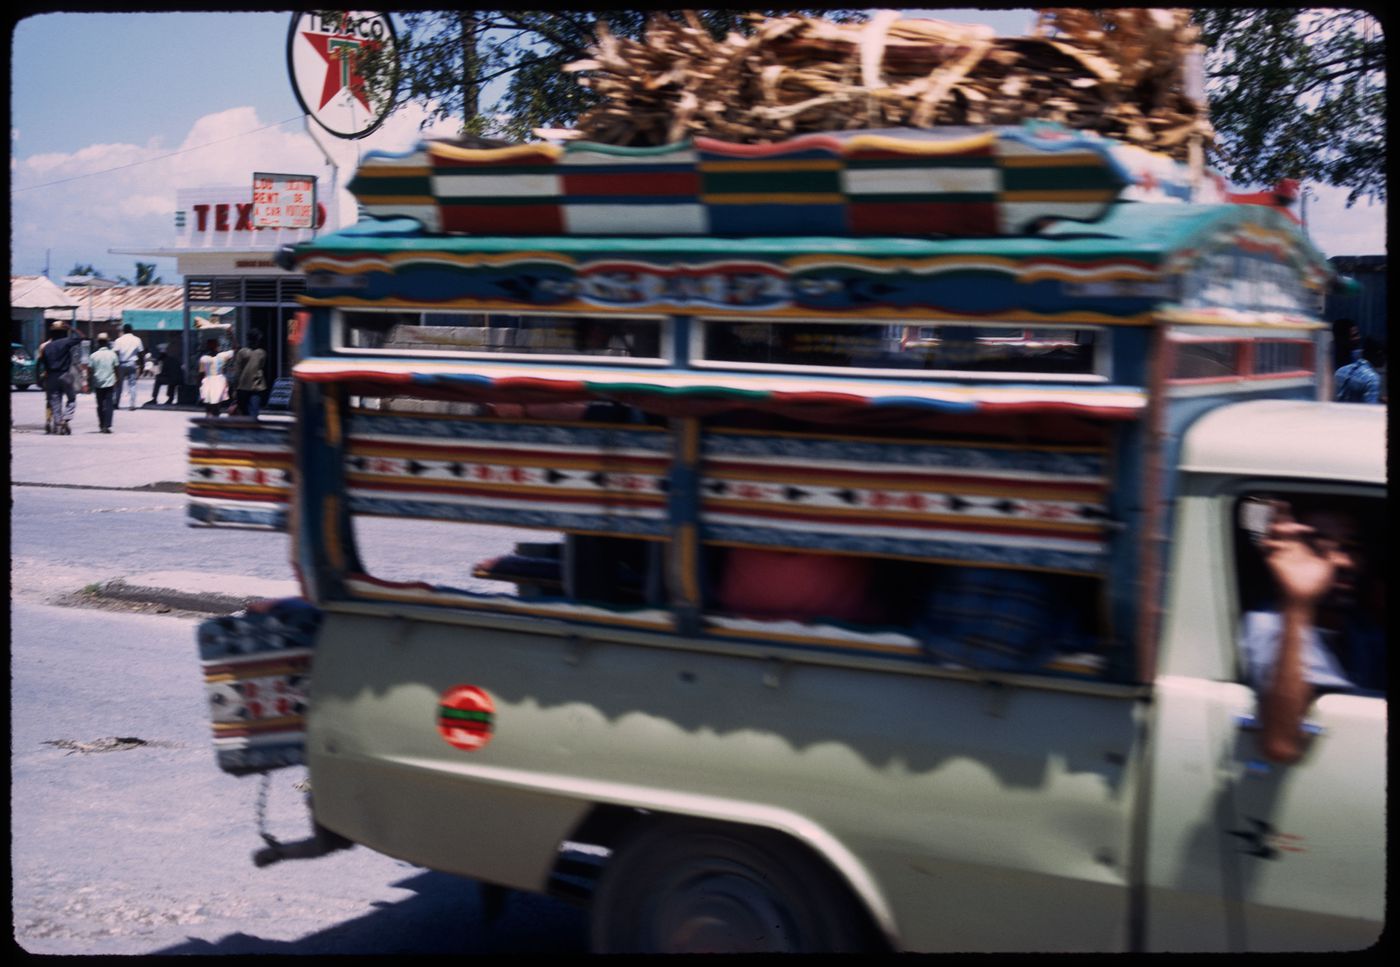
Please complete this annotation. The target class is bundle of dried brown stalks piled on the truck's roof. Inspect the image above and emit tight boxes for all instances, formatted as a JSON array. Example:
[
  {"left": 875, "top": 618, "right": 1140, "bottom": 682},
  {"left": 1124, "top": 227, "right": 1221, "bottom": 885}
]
[{"left": 557, "top": 8, "right": 1212, "bottom": 160}]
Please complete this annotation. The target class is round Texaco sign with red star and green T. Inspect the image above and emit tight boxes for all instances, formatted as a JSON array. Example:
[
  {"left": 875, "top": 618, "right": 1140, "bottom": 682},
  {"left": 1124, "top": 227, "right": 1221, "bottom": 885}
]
[{"left": 287, "top": 10, "right": 395, "bottom": 139}]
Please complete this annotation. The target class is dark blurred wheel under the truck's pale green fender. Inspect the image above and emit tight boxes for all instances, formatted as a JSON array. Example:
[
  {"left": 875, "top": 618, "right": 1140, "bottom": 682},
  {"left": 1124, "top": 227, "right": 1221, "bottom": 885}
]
[{"left": 592, "top": 820, "right": 871, "bottom": 953}]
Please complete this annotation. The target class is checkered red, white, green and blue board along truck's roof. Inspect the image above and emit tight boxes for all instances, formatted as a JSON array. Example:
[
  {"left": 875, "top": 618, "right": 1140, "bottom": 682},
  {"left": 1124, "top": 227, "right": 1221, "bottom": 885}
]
[{"left": 350, "top": 125, "right": 1133, "bottom": 237}]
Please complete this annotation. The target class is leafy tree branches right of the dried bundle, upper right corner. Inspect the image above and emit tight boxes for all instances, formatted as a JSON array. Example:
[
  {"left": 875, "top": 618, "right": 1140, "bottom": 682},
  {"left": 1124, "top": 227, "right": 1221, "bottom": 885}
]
[{"left": 1193, "top": 7, "right": 1386, "bottom": 206}]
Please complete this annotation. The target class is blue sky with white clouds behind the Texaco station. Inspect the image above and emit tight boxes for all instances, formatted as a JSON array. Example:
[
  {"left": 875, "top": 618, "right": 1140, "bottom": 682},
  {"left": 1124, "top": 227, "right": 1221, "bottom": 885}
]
[{"left": 10, "top": 10, "right": 1385, "bottom": 281}]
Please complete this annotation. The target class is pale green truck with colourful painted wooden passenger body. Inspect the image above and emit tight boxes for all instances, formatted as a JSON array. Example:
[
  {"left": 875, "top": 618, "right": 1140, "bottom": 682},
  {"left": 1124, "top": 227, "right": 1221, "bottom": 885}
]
[{"left": 188, "top": 129, "right": 1386, "bottom": 952}]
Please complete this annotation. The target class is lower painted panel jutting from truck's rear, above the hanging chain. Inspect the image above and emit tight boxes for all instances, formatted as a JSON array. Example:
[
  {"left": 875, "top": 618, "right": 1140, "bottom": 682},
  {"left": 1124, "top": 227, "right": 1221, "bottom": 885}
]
[{"left": 197, "top": 598, "right": 321, "bottom": 774}]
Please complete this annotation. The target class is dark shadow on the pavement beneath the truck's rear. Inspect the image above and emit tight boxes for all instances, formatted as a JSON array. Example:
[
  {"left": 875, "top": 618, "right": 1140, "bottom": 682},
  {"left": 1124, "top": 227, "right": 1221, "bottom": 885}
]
[{"left": 151, "top": 870, "right": 588, "bottom": 956}]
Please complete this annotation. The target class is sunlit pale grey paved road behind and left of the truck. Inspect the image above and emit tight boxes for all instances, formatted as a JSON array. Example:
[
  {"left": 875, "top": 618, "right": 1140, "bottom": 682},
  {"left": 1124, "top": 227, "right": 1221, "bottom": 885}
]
[{"left": 10, "top": 383, "right": 587, "bottom": 954}]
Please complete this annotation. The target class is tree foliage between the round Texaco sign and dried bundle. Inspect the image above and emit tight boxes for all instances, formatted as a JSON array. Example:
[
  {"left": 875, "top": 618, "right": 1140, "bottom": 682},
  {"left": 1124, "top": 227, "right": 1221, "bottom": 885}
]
[{"left": 360, "top": 10, "right": 864, "bottom": 140}]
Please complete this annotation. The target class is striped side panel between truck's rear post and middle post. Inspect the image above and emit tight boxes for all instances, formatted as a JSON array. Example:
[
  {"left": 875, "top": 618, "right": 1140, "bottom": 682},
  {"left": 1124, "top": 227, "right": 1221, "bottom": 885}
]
[{"left": 338, "top": 411, "right": 671, "bottom": 537}]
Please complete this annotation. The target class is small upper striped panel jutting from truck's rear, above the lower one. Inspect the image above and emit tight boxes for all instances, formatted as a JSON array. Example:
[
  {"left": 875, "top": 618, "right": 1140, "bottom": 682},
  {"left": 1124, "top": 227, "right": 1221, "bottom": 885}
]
[{"left": 185, "top": 420, "right": 294, "bottom": 530}]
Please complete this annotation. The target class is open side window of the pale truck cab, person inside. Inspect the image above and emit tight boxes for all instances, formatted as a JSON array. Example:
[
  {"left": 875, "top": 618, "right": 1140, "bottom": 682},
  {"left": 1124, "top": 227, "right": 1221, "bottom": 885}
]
[{"left": 1235, "top": 490, "right": 1386, "bottom": 694}]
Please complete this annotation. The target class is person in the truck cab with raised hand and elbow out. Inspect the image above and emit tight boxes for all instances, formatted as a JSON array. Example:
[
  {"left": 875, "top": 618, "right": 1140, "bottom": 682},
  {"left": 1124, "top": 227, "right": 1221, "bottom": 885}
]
[{"left": 1240, "top": 501, "right": 1385, "bottom": 763}]
